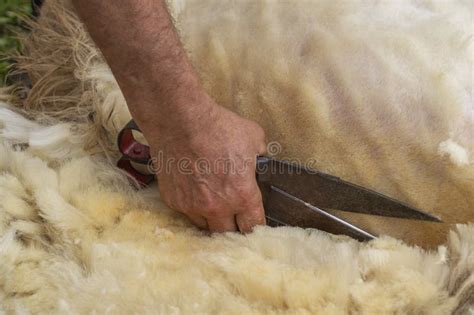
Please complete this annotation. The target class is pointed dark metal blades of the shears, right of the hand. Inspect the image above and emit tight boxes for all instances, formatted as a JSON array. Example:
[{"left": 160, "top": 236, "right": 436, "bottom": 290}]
[{"left": 257, "top": 157, "right": 441, "bottom": 240}]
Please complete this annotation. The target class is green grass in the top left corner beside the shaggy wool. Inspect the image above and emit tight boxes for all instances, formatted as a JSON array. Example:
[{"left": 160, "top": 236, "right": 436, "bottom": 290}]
[{"left": 0, "top": 0, "right": 31, "bottom": 86}]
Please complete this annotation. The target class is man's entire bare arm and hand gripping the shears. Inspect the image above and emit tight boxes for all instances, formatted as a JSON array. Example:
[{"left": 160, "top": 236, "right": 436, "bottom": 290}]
[{"left": 73, "top": 0, "right": 265, "bottom": 232}]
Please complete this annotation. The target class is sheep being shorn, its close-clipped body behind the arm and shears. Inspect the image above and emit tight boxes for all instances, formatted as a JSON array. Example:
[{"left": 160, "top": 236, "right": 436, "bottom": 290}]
[{"left": 12, "top": 1, "right": 474, "bottom": 248}]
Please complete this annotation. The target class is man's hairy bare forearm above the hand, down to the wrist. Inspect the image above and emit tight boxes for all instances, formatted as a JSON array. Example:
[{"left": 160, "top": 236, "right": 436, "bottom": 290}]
[{"left": 73, "top": 0, "right": 210, "bottom": 138}]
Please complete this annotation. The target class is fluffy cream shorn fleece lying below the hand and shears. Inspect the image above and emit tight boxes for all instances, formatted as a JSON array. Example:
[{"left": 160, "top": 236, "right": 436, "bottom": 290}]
[{"left": 0, "top": 144, "right": 474, "bottom": 315}]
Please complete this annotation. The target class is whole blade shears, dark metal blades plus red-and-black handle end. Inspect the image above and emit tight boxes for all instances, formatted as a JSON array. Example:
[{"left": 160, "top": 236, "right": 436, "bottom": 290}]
[{"left": 117, "top": 120, "right": 442, "bottom": 241}]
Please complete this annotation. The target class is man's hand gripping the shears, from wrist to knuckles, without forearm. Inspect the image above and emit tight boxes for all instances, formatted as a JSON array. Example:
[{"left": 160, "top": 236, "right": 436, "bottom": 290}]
[{"left": 145, "top": 95, "right": 266, "bottom": 233}]
